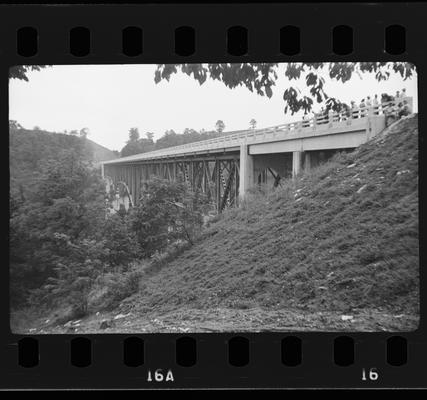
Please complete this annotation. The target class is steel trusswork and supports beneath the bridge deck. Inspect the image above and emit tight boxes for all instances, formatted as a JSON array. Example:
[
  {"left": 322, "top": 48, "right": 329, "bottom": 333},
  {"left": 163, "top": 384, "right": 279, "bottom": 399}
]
[{"left": 104, "top": 145, "right": 350, "bottom": 212}]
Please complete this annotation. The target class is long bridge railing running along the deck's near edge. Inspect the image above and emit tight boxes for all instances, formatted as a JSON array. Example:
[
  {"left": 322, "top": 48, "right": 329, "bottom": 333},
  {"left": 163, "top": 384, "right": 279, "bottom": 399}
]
[{"left": 105, "top": 97, "right": 412, "bottom": 164}]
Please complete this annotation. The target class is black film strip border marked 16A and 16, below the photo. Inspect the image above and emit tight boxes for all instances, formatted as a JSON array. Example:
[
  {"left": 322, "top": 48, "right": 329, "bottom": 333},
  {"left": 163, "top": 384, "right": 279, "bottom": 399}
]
[{"left": 2, "top": 334, "right": 425, "bottom": 388}]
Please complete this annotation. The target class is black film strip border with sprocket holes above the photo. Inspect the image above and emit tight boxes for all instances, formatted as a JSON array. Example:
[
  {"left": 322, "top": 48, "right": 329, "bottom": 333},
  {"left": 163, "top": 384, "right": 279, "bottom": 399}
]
[{"left": 0, "top": 3, "right": 420, "bottom": 64}]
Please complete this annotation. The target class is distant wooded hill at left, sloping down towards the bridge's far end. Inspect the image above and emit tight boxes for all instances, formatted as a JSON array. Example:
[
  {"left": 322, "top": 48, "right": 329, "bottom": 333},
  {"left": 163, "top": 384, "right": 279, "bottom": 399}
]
[{"left": 9, "top": 128, "right": 118, "bottom": 198}]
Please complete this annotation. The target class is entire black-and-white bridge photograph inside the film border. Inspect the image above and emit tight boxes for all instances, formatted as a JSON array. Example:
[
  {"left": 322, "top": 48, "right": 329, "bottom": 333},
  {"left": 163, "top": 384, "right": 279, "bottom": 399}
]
[{"left": 9, "top": 61, "right": 420, "bottom": 335}]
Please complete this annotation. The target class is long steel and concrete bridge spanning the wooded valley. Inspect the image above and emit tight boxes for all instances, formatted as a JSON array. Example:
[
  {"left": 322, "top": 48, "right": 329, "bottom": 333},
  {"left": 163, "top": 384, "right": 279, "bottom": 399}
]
[{"left": 102, "top": 97, "right": 412, "bottom": 212}]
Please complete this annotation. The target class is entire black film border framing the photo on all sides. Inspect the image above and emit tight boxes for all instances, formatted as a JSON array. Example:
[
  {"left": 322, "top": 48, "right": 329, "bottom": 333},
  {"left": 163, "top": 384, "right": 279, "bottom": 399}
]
[{"left": 0, "top": 3, "right": 427, "bottom": 388}]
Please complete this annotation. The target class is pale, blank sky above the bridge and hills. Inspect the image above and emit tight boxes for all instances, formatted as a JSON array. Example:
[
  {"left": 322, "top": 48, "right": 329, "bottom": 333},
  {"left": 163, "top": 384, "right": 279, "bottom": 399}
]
[{"left": 9, "top": 64, "right": 418, "bottom": 150}]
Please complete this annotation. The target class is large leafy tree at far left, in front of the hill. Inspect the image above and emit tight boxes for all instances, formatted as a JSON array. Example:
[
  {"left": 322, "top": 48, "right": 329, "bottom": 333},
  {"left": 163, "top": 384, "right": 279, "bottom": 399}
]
[{"left": 10, "top": 148, "right": 105, "bottom": 306}]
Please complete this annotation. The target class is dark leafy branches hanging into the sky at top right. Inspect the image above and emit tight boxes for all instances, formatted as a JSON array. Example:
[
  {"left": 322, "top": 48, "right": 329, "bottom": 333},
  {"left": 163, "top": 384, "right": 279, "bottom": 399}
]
[{"left": 154, "top": 62, "right": 415, "bottom": 114}]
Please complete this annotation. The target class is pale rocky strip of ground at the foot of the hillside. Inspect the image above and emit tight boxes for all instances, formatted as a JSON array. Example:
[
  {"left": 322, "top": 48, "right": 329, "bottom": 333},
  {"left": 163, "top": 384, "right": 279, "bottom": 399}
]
[{"left": 15, "top": 308, "right": 418, "bottom": 334}]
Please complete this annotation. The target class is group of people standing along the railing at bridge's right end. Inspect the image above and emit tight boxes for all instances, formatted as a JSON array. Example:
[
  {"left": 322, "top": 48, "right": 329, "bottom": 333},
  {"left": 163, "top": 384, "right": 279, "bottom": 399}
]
[{"left": 302, "top": 89, "right": 412, "bottom": 127}]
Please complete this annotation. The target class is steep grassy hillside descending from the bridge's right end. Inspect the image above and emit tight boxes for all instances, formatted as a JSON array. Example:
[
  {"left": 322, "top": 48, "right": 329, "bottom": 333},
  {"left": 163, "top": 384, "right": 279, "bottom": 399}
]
[{"left": 121, "top": 116, "right": 419, "bottom": 329}]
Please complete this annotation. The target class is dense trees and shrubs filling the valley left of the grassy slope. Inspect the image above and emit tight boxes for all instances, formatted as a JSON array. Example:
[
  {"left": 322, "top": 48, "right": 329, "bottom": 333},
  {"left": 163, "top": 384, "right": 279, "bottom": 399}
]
[{"left": 9, "top": 129, "right": 203, "bottom": 332}]
